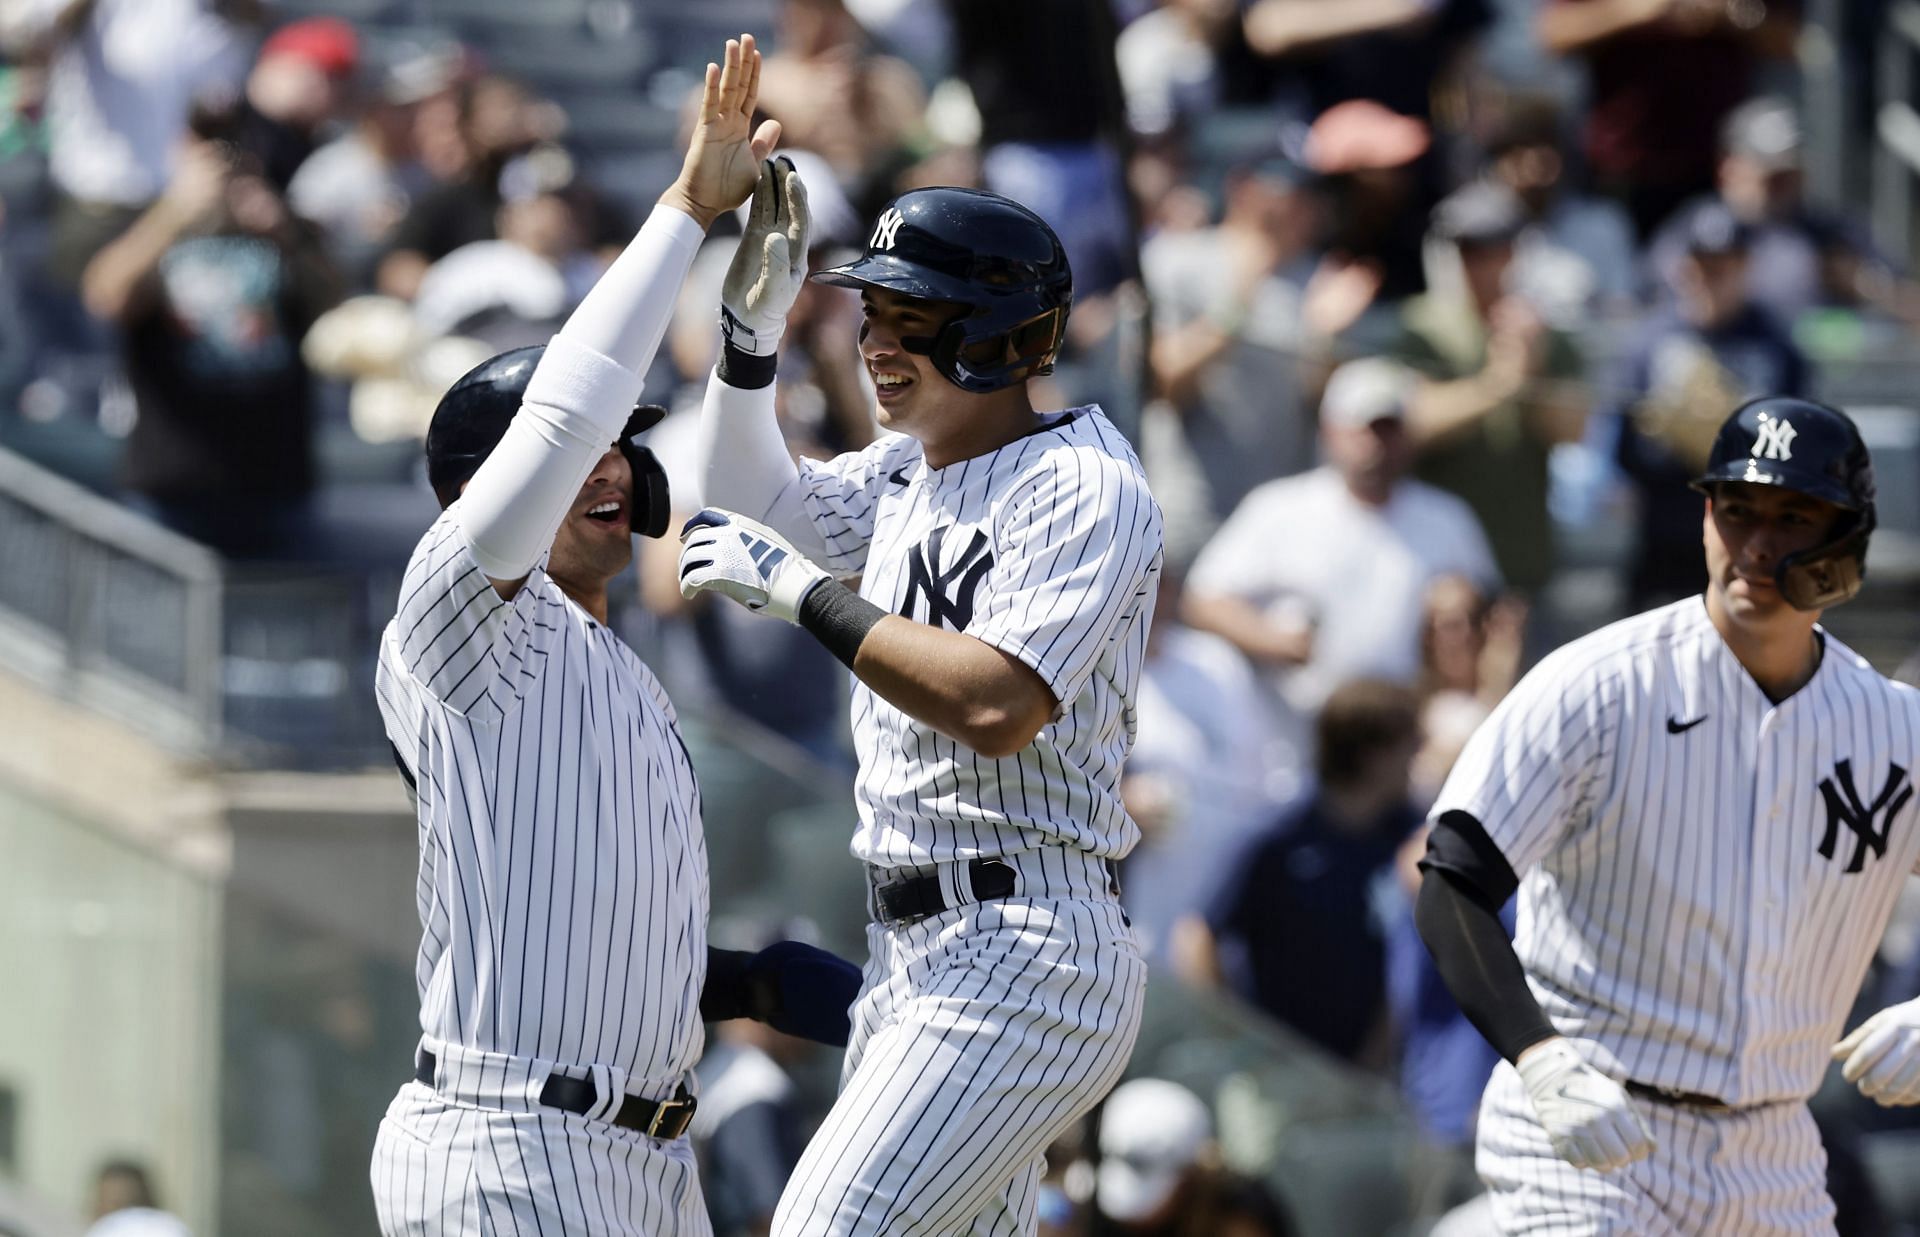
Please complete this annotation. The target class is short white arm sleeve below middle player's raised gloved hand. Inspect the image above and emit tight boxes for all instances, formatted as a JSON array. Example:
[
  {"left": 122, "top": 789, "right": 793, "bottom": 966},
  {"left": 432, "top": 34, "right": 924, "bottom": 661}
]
[{"left": 701, "top": 371, "right": 828, "bottom": 563}]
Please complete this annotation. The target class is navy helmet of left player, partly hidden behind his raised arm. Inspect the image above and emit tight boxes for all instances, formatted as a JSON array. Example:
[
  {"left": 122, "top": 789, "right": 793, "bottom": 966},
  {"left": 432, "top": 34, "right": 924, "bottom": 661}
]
[{"left": 426, "top": 344, "right": 672, "bottom": 538}]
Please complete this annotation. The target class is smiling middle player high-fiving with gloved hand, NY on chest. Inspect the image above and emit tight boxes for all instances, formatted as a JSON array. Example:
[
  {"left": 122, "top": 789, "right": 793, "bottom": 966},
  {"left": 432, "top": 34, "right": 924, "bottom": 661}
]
[{"left": 680, "top": 165, "right": 1162, "bottom": 1237}]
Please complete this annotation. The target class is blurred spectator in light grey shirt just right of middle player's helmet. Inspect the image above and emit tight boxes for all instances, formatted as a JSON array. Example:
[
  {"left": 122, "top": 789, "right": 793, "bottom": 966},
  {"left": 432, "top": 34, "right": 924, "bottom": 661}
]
[{"left": 1140, "top": 159, "right": 1319, "bottom": 519}]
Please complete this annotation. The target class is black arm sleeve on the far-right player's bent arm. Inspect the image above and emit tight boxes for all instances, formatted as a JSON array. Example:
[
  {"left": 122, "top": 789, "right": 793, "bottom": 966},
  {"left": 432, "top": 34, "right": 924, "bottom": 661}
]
[{"left": 1413, "top": 813, "right": 1557, "bottom": 1060}]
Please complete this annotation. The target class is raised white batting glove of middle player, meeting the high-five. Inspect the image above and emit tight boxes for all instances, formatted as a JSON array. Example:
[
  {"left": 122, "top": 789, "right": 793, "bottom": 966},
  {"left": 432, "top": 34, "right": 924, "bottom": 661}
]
[{"left": 720, "top": 159, "right": 812, "bottom": 357}]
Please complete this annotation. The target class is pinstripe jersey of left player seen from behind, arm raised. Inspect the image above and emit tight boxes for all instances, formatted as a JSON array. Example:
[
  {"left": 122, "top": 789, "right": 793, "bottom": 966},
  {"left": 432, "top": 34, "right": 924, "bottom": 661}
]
[{"left": 376, "top": 511, "right": 707, "bottom": 1097}]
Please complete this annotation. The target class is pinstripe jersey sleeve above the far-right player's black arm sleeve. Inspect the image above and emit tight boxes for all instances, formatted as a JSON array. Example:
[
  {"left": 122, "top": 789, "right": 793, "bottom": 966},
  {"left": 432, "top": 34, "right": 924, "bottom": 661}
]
[{"left": 1430, "top": 649, "right": 1607, "bottom": 876}]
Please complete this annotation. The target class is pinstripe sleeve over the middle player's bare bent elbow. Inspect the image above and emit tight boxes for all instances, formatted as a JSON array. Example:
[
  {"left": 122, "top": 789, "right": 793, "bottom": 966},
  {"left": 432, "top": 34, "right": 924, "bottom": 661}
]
[{"left": 968, "top": 448, "right": 1162, "bottom": 707}]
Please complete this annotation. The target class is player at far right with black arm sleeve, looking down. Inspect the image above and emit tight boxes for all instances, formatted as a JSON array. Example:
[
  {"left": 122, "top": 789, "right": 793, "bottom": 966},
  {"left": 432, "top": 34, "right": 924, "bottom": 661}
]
[{"left": 1417, "top": 398, "right": 1920, "bottom": 1237}]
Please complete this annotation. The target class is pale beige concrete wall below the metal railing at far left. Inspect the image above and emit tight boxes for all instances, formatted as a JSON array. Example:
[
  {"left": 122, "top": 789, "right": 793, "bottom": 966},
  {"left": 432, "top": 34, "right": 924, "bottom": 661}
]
[{"left": 0, "top": 678, "right": 223, "bottom": 1233}]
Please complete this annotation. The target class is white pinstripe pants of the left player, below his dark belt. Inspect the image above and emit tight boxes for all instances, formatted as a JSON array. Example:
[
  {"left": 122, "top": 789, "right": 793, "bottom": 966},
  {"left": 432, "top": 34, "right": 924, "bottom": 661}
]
[{"left": 372, "top": 1045, "right": 712, "bottom": 1237}]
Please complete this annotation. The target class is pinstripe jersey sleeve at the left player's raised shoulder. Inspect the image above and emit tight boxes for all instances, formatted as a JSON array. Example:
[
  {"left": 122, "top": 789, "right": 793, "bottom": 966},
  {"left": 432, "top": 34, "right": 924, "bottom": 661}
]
[{"left": 392, "top": 511, "right": 555, "bottom": 722}]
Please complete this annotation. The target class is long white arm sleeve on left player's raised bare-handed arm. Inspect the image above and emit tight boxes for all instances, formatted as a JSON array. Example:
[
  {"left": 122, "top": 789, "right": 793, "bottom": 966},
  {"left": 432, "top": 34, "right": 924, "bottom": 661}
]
[{"left": 453, "top": 206, "right": 703, "bottom": 580}]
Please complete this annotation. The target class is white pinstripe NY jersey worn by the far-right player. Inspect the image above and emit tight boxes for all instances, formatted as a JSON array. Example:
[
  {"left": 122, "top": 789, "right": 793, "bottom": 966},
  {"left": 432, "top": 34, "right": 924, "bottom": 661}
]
[{"left": 1434, "top": 597, "right": 1920, "bottom": 1104}]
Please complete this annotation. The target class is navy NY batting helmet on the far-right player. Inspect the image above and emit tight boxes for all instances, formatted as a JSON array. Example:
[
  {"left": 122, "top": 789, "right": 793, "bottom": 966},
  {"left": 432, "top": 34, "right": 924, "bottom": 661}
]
[{"left": 1693, "top": 396, "right": 1874, "bottom": 611}]
